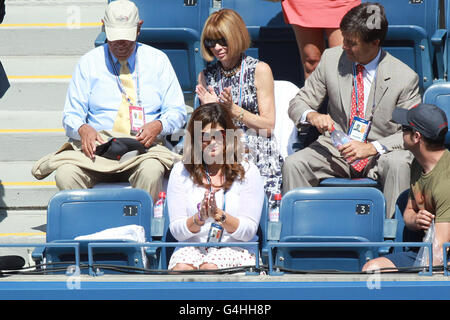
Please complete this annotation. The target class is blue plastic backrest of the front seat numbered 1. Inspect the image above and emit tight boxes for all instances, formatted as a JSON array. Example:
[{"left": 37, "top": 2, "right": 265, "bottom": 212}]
[{"left": 47, "top": 188, "right": 153, "bottom": 242}]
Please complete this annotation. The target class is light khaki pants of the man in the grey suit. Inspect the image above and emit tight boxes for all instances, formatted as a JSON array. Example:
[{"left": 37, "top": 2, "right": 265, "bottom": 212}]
[{"left": 283, "top": 141, "right": 413, "bottom": 218}]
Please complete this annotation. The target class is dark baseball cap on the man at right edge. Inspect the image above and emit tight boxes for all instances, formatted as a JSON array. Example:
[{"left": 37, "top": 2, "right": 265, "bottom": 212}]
[{"left": 392, "top": 103, "right": 448, "bottom": 140}]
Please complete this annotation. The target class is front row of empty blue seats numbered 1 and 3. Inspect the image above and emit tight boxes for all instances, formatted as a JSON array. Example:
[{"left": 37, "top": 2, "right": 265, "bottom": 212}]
[{"left": 33, "top": 187, "right": 420, "bottom": 271}]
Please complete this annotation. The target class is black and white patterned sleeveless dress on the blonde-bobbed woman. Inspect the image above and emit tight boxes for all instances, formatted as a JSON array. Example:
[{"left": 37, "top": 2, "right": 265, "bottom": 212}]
[{"left": 203, "top": 56, "right": 283, "bottom": 206}]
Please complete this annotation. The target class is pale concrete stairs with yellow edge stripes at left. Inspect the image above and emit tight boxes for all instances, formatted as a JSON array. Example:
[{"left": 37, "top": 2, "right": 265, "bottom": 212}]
[{"left": 0, "top": 0, "right": 107, "bottom": 257}]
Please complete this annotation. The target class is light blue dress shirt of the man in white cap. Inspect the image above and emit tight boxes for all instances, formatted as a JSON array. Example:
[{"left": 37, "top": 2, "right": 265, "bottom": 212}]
[{"left": 63, "top": 43, "right": 187, "bottom": 140}]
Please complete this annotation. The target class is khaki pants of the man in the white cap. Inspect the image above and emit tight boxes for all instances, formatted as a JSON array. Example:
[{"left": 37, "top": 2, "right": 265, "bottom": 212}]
[{"left": 55, "top": 159, "right": 165, "bottom": 202}]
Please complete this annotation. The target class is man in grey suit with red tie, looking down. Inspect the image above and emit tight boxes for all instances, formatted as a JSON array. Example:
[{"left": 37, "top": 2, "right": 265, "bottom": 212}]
[{"left": 283, "top": 3, "right": 421, "bottom": 218}]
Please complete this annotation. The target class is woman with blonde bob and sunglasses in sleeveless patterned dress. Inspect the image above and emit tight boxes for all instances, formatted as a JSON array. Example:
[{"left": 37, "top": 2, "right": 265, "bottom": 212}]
[{"left": 196, "top": 9, "right": 283, "bottom": 209}]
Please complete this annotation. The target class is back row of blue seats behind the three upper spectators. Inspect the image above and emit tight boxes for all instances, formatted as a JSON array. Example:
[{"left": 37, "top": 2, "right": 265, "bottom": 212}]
[{"left": 95, "top": 0, "right": 450, "bottom": 93}]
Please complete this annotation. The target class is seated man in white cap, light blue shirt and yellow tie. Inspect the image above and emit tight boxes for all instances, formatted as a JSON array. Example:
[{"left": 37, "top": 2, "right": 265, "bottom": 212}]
[{"left": 55, "top": 0, "right": 186, "bottom": 199}]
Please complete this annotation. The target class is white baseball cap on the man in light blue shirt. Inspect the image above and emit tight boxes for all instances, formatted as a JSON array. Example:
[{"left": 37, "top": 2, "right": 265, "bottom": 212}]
[{"left": 103, "top": 0, "right": 139, "bottom": 41}]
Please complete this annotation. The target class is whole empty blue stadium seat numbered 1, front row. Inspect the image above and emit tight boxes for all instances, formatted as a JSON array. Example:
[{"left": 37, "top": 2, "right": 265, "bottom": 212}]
[{"left": 33, "top": 188, "right": 163, "bottom": 274}]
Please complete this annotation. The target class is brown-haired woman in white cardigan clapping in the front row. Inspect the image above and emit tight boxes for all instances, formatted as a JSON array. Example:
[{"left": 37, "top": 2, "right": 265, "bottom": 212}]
[{"left": 167, "top": 103, "right": 264, "bottom": 270}]
